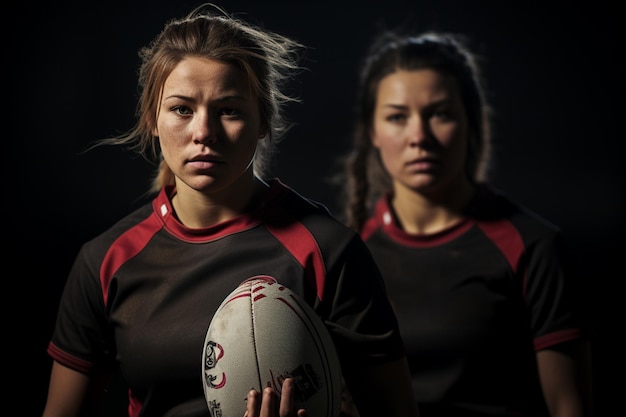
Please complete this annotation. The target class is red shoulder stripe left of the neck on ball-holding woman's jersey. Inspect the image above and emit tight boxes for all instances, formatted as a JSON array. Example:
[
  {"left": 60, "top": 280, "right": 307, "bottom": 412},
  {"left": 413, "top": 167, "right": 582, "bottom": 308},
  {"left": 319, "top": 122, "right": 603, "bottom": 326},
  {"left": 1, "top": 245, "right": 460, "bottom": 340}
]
[{"left": 100, "top": 213, "right": 163, "bottom": 305}]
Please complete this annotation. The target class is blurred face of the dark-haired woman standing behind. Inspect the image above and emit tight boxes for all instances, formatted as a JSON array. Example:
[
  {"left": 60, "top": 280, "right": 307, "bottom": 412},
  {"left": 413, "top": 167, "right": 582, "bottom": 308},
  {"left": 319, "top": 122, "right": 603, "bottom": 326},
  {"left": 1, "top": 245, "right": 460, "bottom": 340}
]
[{"left": 372, "top": 69, "right": 468, "bottom": 193}]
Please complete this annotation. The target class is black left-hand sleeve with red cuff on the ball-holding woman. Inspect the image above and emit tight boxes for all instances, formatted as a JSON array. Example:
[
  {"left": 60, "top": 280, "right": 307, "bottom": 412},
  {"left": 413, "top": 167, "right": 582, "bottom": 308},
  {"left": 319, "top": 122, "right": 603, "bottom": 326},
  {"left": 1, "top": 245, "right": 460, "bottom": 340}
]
[{"left": 48, "top": 240, "right": 115, "bottom": 374}]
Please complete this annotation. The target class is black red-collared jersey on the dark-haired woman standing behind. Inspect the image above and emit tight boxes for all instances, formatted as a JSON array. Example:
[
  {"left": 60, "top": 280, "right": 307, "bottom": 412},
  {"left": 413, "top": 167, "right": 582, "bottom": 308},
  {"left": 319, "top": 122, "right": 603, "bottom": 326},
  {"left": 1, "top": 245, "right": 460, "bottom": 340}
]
[{"left": 362, "top": 187, "right": 582, "bottom": 417}]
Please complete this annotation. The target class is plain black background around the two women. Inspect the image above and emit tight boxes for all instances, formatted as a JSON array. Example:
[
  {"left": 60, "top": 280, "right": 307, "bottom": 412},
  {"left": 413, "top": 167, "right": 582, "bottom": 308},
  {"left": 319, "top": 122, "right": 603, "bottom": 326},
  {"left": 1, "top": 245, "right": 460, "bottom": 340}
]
[{"left": 13, "top": 0, "right": 626, "bottom": 416}]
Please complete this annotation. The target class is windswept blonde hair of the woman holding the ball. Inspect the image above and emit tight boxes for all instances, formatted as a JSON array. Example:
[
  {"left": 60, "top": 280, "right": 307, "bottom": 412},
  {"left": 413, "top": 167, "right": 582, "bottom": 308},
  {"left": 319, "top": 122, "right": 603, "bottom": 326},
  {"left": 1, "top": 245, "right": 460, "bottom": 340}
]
[{"left": 97, "top": 3, "right": 303, "bottom": 192}]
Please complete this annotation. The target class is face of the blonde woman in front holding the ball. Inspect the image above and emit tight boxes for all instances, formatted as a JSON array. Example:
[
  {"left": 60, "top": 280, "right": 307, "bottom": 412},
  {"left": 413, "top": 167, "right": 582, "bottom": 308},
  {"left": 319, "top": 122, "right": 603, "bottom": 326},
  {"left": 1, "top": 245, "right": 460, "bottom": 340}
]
[{"left": 153, "top": 57, "right": 265, "bottom": 193}]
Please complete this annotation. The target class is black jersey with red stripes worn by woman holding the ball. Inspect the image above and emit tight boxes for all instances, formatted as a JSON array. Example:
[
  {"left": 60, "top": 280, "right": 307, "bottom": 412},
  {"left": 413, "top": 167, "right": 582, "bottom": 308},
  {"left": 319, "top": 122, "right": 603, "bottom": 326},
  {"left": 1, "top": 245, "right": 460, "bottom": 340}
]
[{"left": 48, "top": 180, "right": 405, "bottom": 417}]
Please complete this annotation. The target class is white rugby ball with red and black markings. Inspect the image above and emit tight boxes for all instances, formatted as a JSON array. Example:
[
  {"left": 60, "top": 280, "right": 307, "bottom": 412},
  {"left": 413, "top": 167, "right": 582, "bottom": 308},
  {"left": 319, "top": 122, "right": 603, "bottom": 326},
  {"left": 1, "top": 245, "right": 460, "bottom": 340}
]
[{"left": 202, "top": 275, "right": 341, "bottom": 417}]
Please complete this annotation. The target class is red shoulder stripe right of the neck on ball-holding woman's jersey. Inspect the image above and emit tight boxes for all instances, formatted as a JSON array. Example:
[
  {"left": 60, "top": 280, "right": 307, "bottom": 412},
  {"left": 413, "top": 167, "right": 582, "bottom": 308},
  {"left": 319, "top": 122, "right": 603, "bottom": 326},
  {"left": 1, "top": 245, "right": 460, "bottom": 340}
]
[{"left": 266, "top": 211, "right": 326, "bottom": 300}]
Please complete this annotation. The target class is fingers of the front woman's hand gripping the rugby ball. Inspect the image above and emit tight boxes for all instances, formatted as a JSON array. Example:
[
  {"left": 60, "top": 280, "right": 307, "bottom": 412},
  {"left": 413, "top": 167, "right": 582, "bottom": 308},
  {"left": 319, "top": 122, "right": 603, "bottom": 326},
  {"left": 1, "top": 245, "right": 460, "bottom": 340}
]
[{"left": 244, "top": 378, "right": 307, "bottom": 417}]
